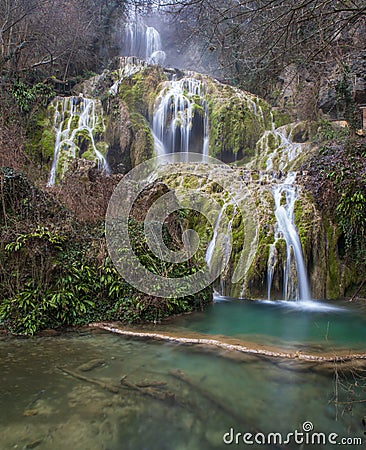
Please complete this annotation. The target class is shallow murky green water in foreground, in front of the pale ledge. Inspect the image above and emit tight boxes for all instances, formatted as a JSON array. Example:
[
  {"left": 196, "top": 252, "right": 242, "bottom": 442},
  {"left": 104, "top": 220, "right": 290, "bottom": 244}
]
[{"left": 0, "top": 332, "right": 365, "bottom": 450}]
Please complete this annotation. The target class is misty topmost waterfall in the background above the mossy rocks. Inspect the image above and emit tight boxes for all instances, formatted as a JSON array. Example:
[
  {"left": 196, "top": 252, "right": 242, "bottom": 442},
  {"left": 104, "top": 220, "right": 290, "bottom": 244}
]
[{"left": 122, "top": 19, "right": 166, "bottom": 65}]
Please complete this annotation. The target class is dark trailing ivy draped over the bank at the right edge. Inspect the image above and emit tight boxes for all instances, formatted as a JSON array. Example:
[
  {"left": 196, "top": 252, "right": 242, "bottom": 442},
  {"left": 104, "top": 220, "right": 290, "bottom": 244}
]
[{"left": 302, "top": 132, "right": 366, "bottom": 271}]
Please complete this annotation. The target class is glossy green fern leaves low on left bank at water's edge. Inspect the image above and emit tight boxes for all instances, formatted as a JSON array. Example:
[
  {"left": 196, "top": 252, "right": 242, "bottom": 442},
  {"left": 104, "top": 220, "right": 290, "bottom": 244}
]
[{"left": 0, "top": 214, "right": 211, "bottom": 335}]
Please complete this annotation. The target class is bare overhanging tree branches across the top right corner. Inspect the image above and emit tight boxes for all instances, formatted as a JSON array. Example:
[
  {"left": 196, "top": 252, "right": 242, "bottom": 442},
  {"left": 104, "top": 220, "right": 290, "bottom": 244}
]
[{"left": 162, "top": 0, "right": 366, "bottom": 96}]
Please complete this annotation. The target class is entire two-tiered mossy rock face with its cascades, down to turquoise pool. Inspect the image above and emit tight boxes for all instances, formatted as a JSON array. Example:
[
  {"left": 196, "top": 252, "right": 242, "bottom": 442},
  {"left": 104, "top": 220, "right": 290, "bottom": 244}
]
[{"left": 32, "top": 57, "right": 364, "bottom": 299}]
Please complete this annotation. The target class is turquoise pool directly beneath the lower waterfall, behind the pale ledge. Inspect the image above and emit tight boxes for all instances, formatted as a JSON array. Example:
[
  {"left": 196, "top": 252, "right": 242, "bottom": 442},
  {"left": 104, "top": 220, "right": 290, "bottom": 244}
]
[{"left": 155, "top": 296, "right": 366, "bottom": 352}]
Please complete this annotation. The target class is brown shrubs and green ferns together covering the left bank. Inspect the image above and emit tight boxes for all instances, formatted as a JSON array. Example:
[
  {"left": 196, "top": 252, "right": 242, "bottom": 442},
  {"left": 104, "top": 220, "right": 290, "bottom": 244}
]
[{"left": 0, "top": 169, "right": 211, "bottom": 334}]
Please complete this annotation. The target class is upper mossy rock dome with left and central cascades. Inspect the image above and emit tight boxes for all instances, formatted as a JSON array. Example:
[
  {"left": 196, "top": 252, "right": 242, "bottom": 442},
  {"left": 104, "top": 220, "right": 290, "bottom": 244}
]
[{"left": 38, "top": 57, "right": 276, "bottom": 184}]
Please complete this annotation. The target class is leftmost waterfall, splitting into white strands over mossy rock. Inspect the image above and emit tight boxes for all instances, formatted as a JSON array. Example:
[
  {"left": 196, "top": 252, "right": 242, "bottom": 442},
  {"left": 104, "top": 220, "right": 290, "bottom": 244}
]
[{"left": 47, "top": 95, "right": 109, "bottom": 186}]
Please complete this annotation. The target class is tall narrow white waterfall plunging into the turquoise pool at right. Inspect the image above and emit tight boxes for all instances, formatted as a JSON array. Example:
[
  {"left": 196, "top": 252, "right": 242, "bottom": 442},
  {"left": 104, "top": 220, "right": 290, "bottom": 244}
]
[{"left": 267, "top": 172, "right": 311, "bottom": 300}]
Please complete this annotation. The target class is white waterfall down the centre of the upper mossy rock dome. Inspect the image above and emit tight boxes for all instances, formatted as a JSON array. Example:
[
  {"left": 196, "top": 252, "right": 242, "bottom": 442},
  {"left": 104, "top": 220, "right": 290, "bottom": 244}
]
[{"left": 152, "top": 77, "right": 209, "bottom": 157}]
